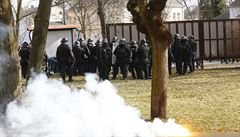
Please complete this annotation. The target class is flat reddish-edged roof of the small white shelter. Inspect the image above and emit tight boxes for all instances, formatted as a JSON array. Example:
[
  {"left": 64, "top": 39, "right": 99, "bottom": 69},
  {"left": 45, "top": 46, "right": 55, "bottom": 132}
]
[{"left": 27, "top": 24, "right": 80, "bottom": 31}]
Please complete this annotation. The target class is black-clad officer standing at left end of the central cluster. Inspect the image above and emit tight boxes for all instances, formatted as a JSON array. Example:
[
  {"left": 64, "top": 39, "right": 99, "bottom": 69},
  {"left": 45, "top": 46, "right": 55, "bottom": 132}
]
[{"left": 56, "top": 41, "right": 75, "bottom": 81}]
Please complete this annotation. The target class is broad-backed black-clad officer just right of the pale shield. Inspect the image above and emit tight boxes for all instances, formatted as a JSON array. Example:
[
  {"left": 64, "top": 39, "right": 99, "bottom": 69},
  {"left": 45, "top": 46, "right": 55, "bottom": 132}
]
[{"left": 113, "top": 40, "right": 131, "bottom": 79}]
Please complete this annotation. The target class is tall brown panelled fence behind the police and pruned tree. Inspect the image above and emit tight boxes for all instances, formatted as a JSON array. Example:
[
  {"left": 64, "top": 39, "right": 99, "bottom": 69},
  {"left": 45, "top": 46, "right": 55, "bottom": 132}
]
[{"left": 107, "top": 19, "right": 240, "bottom": 60}]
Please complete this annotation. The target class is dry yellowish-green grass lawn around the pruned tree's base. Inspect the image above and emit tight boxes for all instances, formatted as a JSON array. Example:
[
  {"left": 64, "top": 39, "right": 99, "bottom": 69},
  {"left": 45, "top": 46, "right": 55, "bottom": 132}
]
[{"left": 63, "top": 68, "right": 240, "bottom": 133}]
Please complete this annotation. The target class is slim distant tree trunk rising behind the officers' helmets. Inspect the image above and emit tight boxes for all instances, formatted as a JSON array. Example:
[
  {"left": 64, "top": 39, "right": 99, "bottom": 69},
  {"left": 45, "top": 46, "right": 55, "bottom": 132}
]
[{"left": 98, "top": 0, "right": 106, "bottom": 38}]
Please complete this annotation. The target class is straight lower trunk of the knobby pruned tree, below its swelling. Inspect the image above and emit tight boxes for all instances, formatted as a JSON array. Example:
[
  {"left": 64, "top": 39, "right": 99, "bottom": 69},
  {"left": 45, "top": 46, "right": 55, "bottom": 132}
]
[{"left": 150, "top": 36, "right": 168, "bottom": 119}]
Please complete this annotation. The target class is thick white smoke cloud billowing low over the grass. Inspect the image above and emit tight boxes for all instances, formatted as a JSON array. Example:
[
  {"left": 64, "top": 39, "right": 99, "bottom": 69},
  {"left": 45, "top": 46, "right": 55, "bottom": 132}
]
[{"left": 0, "top": 75, "right": 191, "bottom": 137}]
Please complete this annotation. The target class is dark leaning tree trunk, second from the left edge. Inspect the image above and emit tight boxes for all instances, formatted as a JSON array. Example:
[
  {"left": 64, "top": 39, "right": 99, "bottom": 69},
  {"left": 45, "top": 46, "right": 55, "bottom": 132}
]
[{"left": 28, "top": 0, "right": 52, "bottom": 78}]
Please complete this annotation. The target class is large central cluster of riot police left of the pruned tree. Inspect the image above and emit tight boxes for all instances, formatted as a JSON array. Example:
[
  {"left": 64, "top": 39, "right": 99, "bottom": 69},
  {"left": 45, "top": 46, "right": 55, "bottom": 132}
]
[{"left": 56, "top": 37, "right": 151, "bottom": 81}]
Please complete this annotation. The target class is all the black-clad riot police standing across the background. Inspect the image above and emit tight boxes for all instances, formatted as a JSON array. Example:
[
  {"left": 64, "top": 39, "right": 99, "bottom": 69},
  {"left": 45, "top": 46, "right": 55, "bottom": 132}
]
[{"left": 19, "top": 34, "right": 197, "bottom": 81}]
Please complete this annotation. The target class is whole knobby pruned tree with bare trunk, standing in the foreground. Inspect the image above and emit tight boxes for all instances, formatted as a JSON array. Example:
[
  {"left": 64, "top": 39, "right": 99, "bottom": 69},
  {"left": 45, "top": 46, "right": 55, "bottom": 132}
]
[{"left": 127, "top": 0, "right": 172, "bottom": 119}]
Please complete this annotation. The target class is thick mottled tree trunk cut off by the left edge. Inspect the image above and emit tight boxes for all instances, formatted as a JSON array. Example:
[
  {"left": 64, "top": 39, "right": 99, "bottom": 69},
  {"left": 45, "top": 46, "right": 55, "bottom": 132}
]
[{"left": 0, "top": 0, "right": 21, "bottom": 111}]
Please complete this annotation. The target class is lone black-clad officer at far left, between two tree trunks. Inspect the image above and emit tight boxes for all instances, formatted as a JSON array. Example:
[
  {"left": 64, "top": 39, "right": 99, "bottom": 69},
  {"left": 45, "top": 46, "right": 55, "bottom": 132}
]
[{"left": 18, "top": 42, "right": 30, "bottom": 78}]
